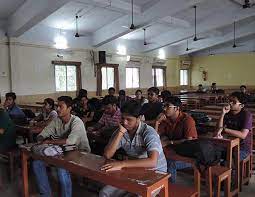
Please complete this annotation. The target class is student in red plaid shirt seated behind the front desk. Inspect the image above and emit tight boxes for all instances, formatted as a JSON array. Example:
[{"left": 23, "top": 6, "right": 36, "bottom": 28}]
[{"left": 88, "top": 95, "right": 121, "bottom": 133}]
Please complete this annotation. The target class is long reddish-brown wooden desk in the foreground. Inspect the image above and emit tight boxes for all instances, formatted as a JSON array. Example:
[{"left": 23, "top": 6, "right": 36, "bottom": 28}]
[{"left": 21, "top": 147, "right": 170, "bottom": 197}]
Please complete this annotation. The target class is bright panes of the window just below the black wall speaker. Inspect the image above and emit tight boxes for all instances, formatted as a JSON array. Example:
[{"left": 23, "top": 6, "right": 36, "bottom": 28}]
[{"left": 102, "top": 67, "right": 114, "bottom": 90}]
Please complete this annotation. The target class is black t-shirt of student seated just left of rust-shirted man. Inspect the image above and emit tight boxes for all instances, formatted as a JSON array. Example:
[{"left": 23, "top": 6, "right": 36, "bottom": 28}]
[{"left": 140, "top": 102, "right": 163, "bottom": 120}]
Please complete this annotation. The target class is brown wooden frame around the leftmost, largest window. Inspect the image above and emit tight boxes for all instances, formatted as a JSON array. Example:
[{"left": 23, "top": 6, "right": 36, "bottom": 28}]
[{"left": 51, "top": 61, "right": 82, "bottom": 92}]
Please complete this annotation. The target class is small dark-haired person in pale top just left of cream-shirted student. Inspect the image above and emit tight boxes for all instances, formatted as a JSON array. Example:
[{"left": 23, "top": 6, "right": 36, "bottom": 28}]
[{"left": 34, "top": 98, "right": 58, "bottom": 124}]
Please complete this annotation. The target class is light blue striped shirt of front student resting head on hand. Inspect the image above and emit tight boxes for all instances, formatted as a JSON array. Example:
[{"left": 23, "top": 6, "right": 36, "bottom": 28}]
[{"left": 110, "top": 122, "right": 167, "bottom": 172}]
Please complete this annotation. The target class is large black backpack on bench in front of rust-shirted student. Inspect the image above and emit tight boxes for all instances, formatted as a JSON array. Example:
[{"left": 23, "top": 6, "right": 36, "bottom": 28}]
[{"left": 172, "top": 139, "right": 226, "bottom": 172}]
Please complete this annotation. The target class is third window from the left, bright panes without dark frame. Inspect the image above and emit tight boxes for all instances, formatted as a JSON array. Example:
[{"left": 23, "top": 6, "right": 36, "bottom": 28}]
[{"left": 126, "top": 68, "right": 139, "bottom": 88}]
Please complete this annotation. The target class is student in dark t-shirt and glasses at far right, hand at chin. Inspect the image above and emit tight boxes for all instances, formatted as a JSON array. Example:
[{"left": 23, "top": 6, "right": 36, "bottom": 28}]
[{"left": 215, "top": 92, "right": 252, "bottom": 161}]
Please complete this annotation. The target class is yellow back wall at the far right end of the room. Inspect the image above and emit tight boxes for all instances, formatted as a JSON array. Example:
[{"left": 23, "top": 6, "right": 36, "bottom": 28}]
[{"left": 191, "top": 53, "right": 255, "bottom": 88}]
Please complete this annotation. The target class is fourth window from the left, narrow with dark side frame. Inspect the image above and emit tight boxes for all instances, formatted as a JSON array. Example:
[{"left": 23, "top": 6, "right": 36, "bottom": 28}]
[{"left": 152, "top": 66, "right": 166, "bottom": 87}]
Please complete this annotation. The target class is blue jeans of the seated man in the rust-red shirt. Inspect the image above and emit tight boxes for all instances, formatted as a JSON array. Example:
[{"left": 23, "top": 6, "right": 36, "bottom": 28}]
[{"left": 167, "top": 159, "right": 191, "bottom": 183}]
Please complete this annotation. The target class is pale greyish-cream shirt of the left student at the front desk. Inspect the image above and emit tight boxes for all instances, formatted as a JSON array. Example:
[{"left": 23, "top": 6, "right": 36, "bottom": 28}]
[{"left": 38, "top": 115, "right": 90, "bottom": 152}]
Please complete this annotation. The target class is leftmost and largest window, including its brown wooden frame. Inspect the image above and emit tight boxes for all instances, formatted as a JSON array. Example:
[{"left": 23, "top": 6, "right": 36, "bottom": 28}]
[{"left": 52, "top": 61, "right": 81, "bottom": 92}]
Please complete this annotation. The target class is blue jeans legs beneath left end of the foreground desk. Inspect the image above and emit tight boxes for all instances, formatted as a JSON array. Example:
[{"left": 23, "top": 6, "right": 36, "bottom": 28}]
[{"left": 32, "top": 160, "right": 72, "bottom": 197}]
